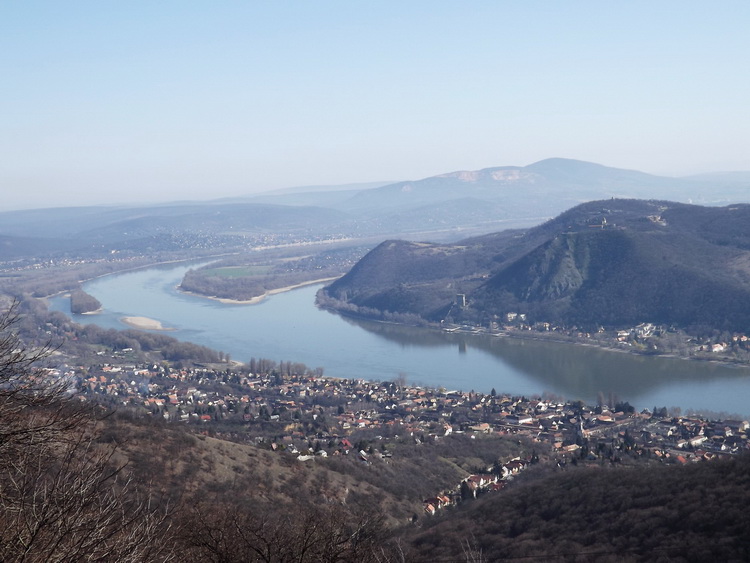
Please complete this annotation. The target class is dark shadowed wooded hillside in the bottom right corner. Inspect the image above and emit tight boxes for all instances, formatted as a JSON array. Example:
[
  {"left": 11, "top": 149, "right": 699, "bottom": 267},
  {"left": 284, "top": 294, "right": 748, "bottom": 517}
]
[{"left": 411, "top": 456, "right": 750, "bottom": 561}]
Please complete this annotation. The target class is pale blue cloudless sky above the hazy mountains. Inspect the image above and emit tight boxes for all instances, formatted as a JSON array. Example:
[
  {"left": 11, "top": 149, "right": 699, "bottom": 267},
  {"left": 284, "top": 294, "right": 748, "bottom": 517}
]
[{"left": 0, "top": 0, "right": 750, "bottom": 211}]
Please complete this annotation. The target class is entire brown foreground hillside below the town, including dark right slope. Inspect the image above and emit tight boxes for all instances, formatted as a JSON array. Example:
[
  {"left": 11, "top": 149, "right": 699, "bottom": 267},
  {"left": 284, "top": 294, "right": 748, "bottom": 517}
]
[{"left": 19, "top": 400, "right": 750, "bottom": 562}]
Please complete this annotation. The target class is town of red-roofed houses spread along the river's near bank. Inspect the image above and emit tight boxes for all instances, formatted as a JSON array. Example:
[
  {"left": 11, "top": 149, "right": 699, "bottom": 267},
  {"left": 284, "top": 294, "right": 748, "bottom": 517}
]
[{"left": 50, "top": 350, "right": 750, "bottom": 514}]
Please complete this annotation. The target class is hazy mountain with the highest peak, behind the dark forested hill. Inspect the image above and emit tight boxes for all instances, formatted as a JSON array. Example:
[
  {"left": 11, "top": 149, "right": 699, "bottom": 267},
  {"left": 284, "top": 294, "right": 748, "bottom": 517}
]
[{"left": 338, "top": 158, "right": 750, "bottom": 217}]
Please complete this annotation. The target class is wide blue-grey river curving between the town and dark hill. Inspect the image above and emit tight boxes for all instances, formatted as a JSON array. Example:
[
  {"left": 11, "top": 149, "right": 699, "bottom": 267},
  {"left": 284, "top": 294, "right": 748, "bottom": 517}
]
[{"left": 50, "top": 265, "right": 750, "bottom": 417}]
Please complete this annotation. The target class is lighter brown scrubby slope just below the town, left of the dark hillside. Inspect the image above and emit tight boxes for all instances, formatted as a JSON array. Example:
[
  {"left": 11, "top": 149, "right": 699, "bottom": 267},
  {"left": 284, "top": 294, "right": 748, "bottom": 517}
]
[{"left": 101, "top": 413, "right": 531, "bottom": 526}]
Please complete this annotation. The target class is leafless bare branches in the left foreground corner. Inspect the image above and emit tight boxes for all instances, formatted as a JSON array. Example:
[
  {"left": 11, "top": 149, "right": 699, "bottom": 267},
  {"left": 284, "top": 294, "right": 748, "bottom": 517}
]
[{"left": 0, "top": 306, "right": 173, "bottom": 562}]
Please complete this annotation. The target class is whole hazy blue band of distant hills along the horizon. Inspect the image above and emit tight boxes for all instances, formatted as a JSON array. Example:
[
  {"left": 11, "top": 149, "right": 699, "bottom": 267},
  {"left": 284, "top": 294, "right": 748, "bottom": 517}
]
[{"left": 0, "top": 158, "right": 750, "bottom": 259}]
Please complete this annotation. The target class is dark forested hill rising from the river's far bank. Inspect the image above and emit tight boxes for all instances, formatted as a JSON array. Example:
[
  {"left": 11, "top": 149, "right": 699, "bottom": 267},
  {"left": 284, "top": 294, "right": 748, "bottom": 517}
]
[{"left": 322, "top": 199, "right": 750, "bottom": 331}]
